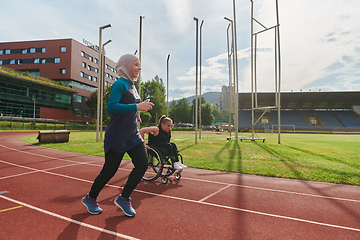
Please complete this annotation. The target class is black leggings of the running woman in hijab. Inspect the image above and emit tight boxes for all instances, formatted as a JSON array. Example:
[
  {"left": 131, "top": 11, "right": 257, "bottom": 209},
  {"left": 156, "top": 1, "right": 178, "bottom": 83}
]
[{"left": 89, "top": 143, "right": 148, "bottom": 198}]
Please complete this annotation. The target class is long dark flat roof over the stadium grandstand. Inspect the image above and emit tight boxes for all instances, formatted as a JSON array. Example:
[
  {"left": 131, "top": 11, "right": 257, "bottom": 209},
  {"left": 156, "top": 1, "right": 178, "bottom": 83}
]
[{"left": 239, "top": 91, "right": 360, "bottom": 109}]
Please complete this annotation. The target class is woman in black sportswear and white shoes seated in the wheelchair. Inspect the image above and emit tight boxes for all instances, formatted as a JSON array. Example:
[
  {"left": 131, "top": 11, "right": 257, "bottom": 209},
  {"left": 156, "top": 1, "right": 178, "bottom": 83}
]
[{"left": 139, "top": 115, "right": 187, "bottom": 170}]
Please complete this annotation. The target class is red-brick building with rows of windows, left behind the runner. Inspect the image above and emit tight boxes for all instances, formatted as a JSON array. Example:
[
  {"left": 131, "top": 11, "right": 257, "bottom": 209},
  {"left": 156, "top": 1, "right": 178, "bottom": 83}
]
[{"left": 0, "top": 39, "right": 119, "bottom": 122}]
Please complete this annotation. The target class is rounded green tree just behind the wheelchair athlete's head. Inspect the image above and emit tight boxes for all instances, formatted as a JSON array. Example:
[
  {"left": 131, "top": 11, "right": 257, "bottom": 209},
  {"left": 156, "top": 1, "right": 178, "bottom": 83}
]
[{"left": 169, "top": 98, "right": 191, "bottom": 123}]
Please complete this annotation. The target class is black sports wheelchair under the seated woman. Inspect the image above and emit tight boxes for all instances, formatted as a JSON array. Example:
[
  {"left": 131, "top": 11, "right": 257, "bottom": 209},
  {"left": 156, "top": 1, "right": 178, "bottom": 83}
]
[{"left": 143, "top": 135, "right": 183, "bottom": 184}]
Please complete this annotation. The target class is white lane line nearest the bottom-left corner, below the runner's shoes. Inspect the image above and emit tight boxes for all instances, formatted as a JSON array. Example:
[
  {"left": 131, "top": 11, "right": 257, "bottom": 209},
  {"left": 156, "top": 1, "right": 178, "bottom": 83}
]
[{"left": 0, "top": 195, "right": 139, "bottom": 240}]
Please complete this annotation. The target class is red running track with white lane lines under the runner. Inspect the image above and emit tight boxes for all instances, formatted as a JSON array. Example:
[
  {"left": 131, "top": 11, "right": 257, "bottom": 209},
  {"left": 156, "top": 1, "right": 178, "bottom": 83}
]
[{"left": 0, "top": 132, "right": 360, "bottom": 240}]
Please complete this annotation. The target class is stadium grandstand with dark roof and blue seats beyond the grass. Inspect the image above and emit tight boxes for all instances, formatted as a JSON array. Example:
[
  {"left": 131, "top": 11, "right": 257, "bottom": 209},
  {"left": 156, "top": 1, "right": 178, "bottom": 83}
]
[{"left": 219, "top": 87, "right": 360, "bottom": 132}]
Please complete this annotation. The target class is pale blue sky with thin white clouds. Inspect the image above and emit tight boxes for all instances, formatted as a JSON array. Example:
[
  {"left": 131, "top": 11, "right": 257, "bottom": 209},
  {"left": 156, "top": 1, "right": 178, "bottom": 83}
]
[{"left": 0, "top": 0, "right": 360, "bottom": 100}]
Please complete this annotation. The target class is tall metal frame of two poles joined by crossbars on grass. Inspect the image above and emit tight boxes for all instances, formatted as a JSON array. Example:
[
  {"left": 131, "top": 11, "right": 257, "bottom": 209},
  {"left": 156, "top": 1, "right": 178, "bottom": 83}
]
[{"left": 248, "top": 0, "right": 281, "bottom": 143}]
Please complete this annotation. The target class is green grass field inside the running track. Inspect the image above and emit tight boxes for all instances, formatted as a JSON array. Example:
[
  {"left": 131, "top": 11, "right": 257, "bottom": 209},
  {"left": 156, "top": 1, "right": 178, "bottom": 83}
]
[{"left": 23, "top": 132, "right": 360, "bottom": 186}]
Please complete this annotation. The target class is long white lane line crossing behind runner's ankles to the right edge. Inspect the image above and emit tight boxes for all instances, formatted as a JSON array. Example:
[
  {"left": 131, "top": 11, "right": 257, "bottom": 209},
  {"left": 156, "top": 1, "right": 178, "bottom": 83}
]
[{"left": 0, "top": 161, "right": 360, "bottom": 232}]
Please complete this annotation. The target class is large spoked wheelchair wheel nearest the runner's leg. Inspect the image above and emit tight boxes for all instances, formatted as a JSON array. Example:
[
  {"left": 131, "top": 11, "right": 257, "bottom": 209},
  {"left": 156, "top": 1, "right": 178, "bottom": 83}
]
[{"left": 143, "top": 147, "right": 164, "bottom": 181}]
